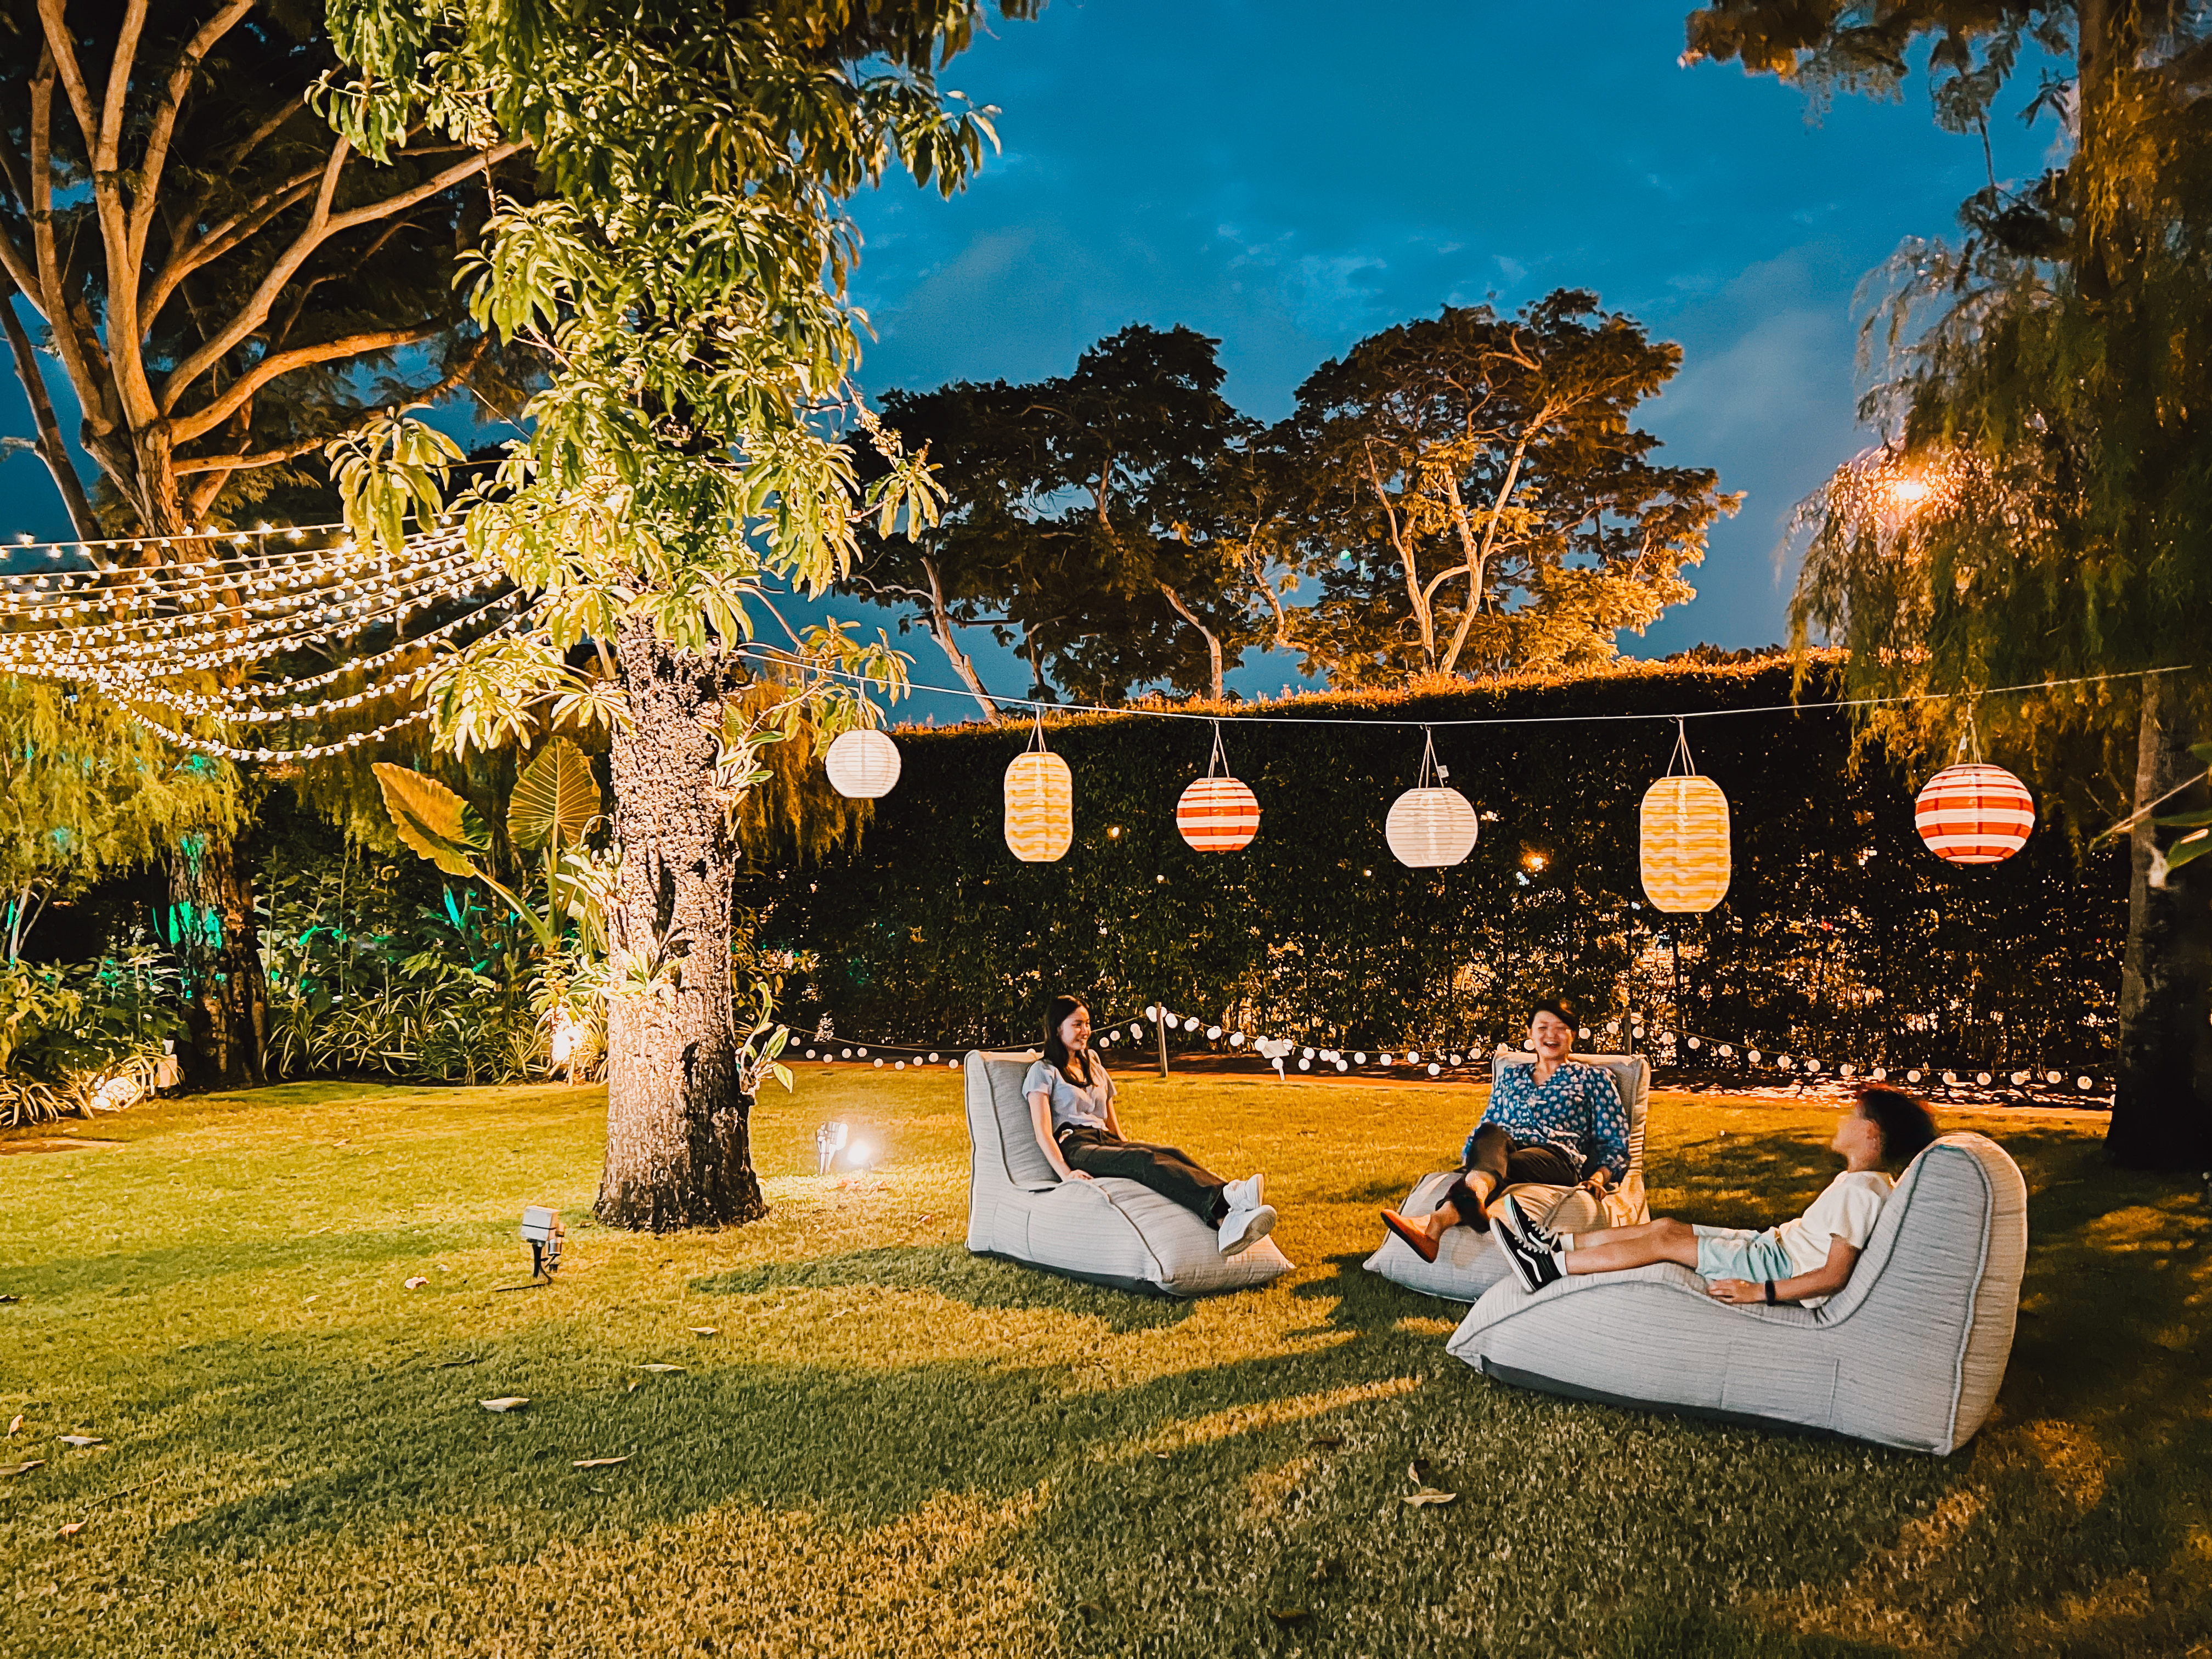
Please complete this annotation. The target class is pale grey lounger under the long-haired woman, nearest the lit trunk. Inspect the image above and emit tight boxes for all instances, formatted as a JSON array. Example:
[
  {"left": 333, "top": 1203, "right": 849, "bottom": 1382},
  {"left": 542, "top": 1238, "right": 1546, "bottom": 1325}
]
[{"left": 962, "top": 1053, "right": 1290, "bottom": 1296}]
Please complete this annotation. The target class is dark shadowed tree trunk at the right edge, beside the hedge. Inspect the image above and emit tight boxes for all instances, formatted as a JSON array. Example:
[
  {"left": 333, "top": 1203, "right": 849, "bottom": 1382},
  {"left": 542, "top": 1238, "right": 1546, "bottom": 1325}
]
[{"left": 2103, "top": 675, "right": 2212, "bottom": 1170}]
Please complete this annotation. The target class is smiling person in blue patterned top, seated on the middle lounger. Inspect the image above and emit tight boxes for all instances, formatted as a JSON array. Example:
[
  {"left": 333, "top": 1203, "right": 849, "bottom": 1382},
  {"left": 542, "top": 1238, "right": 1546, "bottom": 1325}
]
[{"left": 1383, "top": 1002, "right": 1628, "bottom": 1261}]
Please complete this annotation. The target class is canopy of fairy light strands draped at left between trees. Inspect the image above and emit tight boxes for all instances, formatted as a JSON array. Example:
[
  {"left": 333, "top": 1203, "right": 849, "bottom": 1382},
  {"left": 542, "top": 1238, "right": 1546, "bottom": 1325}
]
[{"left": 0, "top": 524, "right": 526, "bottom": 763}]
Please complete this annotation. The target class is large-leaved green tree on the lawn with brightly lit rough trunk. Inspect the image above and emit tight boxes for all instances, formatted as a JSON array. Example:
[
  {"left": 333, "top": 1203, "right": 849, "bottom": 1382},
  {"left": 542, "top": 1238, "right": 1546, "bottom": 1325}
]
[{"left": 328, "top": 0, "right": 1033, "bottom": 1228}]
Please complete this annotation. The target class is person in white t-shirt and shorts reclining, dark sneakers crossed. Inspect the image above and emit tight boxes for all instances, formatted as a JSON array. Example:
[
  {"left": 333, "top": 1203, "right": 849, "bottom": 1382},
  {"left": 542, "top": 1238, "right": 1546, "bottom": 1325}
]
[{"left": 1493, "top": 1084, "right": 1936, "bottom": 1307}]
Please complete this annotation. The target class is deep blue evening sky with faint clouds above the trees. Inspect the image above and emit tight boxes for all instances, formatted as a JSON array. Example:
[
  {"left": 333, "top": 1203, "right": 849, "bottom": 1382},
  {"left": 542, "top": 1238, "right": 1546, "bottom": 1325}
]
[{"left": 0, "top": 0, "right": 2049, "bottom": 719}]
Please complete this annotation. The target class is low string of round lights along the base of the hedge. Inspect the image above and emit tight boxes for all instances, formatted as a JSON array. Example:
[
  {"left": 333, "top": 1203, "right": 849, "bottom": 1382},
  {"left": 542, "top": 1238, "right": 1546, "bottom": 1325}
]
[{"left": 778, "top": 1005, "right": 2099, "bottom": 1095}]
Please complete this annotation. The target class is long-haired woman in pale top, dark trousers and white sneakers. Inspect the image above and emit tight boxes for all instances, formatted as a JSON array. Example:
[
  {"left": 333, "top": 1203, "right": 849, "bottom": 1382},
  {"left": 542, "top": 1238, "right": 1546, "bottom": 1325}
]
[{"left": 1022, "top": 995, "right": 1274, "bottom": 1256}]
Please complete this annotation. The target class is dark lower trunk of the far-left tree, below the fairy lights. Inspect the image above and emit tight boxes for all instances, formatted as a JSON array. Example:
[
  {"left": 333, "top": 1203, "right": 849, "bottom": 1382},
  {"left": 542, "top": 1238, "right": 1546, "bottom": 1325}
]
[{"left": 170, "top": 832, "right": 270, "bottom": 1088}]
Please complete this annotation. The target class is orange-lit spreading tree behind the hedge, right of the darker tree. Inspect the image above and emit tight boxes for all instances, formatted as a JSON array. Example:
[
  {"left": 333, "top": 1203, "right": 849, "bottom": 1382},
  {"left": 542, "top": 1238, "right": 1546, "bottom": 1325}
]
[{"left": 1272, "top": 290, "right": 1741, "bottom": 684}]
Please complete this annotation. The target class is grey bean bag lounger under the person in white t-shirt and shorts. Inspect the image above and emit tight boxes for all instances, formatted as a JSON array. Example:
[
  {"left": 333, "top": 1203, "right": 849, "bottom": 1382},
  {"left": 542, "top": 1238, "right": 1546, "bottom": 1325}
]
[{"left": 1447, "top": 1135, "right": 2028, "bottom": 1455}]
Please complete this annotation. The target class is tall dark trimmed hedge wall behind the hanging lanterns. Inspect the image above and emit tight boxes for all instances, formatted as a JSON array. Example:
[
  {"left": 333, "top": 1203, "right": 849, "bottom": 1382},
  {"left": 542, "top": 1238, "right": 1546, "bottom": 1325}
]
[{"left": 743, "top": 662, "right": 2126, "bottom": 1073}]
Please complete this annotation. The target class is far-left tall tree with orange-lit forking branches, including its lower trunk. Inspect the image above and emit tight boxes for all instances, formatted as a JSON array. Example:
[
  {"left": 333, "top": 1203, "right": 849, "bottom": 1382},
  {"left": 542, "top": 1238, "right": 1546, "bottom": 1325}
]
[{"left": 0, "top": 0, "right": 527, "bottom": 1084}]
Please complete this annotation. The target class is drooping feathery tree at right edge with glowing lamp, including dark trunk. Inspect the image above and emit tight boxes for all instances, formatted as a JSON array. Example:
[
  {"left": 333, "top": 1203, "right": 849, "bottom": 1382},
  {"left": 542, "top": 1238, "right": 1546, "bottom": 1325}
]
[{"left": 1688, "top": 0, "right": 2212, "bottom": 1170}]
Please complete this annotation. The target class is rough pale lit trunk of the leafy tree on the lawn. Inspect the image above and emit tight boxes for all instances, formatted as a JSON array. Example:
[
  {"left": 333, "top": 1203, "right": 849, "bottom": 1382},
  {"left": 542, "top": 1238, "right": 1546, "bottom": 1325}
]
[{"left": 597, "top": 622, "right": 768, "bottom": 1232}]
